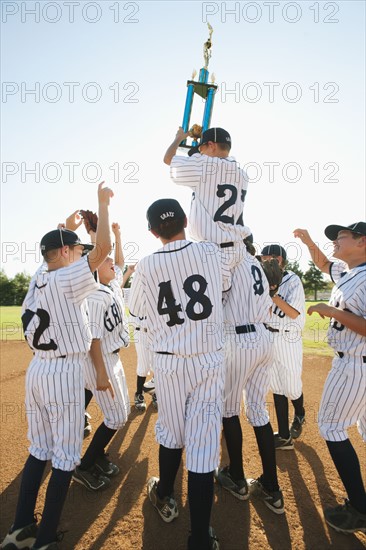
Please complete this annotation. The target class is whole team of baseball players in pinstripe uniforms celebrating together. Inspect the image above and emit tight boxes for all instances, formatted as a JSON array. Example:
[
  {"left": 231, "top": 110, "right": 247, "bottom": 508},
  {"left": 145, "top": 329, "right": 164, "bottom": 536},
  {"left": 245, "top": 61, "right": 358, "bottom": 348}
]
[{"left": 1, "top": 128, "right": 366, "bottom": 550}]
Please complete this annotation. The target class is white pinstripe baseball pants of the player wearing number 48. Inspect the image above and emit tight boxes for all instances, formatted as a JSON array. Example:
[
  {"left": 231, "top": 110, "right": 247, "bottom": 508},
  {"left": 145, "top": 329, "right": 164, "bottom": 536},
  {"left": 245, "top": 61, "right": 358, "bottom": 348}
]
[{"left": 153, "top": 352, "right": 224, "bottom": 473}]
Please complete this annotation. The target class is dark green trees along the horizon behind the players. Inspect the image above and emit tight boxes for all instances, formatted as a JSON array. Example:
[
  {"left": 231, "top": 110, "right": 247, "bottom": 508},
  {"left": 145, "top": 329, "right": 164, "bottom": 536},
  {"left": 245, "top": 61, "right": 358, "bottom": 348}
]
[{"left": 0, "top": 261, "right": 332, "bottom": 306}]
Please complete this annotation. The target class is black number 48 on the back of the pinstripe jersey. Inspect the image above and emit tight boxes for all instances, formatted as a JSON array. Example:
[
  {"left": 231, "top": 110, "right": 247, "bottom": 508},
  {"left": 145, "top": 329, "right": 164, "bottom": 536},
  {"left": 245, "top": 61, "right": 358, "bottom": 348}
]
[{"left": 158, "top": 275, "right": 212, "bottom": 327}]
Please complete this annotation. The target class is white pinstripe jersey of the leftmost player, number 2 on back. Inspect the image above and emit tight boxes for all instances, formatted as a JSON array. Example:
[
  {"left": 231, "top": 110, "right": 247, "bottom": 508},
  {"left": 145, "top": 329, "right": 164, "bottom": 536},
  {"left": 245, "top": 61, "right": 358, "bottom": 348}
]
[{"left": 22, "top": 257, "right": 98, "bottom": 359}]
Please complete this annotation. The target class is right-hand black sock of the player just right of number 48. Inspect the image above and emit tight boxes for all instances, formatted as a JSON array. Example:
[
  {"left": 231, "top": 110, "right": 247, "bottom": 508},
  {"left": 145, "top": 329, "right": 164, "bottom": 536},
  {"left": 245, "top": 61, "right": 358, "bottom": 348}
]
[{"left": 254, "top": 422, "right": 279, "bottom": 491}]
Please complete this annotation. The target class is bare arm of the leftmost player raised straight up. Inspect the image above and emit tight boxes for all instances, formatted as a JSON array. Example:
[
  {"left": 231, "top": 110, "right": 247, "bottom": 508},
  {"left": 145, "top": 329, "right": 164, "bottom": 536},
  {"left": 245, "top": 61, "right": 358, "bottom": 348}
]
[{"left": 89, "top": 181, "right": 113, "bottom": 272}]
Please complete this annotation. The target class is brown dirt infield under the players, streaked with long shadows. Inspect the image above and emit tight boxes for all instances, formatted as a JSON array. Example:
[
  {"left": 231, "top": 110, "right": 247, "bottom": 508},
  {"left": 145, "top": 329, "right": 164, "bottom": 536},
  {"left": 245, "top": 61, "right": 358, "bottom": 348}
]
[{"left": 0, "top": 342, "right": 366, "bottom": 550}]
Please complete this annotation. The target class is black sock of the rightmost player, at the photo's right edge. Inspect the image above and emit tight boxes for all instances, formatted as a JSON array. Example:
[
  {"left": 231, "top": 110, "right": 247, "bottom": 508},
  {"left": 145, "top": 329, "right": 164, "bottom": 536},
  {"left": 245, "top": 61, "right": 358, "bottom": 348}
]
[{"left": 326, "top": 439, "right": 366, "bottom": 514}]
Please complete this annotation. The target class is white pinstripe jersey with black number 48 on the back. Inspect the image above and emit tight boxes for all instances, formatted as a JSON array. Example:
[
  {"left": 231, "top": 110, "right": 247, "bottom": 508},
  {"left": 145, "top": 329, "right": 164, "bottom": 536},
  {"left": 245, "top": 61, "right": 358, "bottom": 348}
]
[{"left": 130, "top": 240, "right": 226, "bottom": 356}]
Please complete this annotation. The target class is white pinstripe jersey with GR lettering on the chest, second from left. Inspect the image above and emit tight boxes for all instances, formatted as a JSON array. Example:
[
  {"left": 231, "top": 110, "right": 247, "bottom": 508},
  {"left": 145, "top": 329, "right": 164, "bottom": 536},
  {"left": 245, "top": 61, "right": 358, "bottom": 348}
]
[{"left": 88, "top": 266, "right": 129, "bottom": 355}]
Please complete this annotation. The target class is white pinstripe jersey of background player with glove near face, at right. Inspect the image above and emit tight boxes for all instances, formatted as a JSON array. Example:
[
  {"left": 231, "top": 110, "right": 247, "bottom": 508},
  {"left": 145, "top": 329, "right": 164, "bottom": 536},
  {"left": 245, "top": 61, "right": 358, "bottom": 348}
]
[{"left": 269, "top": 271, "right": 305, "bottom": 332}]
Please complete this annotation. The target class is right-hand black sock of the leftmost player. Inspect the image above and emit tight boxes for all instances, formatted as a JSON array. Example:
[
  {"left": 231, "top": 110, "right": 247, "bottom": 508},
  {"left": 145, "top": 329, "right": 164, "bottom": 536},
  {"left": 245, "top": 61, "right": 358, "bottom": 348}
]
[{"left": 34, "top": 468, "right": 72, "bottom": 548}]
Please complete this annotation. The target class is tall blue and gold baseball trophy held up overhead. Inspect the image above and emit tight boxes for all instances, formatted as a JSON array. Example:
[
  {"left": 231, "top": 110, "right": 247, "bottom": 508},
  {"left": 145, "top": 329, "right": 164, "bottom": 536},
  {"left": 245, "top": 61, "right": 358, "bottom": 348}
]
[{"left": 179, "top": 23, "right": 217, "bottom": 149}]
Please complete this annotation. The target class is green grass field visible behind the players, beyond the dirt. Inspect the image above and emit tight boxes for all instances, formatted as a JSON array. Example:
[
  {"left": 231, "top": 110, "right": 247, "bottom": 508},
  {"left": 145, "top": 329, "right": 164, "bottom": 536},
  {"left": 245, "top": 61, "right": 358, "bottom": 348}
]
[{"left": 0, "top": 302, "right": 333, "bottom": 355}]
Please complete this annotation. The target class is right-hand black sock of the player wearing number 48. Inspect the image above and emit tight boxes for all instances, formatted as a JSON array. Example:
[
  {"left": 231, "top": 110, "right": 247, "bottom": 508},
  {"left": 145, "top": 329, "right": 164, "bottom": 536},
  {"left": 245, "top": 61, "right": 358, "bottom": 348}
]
[{"left": 188, "top": 471, "right": 214, "bottom": 550}]
